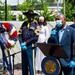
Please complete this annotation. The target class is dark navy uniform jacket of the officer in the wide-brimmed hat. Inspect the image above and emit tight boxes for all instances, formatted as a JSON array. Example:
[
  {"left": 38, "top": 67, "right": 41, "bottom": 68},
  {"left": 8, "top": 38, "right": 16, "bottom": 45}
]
[{"left": 19, "top": 21, "right": 39, "bottom": 46}]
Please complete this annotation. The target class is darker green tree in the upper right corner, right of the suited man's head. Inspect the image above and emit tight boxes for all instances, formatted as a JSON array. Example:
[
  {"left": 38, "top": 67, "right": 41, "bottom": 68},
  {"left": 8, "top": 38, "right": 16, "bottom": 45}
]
[{"left": 62, "top": 0, "right": 75, "bottom": 21}]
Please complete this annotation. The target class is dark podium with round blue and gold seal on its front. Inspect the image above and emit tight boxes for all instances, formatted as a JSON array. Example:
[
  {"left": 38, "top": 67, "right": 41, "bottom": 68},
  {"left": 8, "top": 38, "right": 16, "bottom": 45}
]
[{"left": 36, "top": 43, "right": 68, "bottom": 75}]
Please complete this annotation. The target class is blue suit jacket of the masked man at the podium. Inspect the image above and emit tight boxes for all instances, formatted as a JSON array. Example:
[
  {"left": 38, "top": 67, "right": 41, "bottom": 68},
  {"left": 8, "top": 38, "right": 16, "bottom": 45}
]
[{"left": 48, "top": 26, "right": 75, "bottom": 67}]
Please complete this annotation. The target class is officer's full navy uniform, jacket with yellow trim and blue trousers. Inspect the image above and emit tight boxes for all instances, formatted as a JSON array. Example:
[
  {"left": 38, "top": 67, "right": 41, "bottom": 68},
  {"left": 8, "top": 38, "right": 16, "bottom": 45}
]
[{"left": 19, "top": 20, "right": 40, "bottom": 75}]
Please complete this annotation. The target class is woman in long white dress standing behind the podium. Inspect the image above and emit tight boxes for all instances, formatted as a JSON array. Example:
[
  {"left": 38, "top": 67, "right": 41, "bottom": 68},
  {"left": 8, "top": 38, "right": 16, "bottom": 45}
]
[{"left": 35, "top": 16, "right": 50, "bottom": 74}]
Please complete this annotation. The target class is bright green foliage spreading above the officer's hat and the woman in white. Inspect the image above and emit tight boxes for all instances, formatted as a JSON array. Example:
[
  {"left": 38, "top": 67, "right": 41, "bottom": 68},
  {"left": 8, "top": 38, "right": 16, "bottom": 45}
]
[{"left": 17, "top": 0, "right": 54, "bottom": 21}]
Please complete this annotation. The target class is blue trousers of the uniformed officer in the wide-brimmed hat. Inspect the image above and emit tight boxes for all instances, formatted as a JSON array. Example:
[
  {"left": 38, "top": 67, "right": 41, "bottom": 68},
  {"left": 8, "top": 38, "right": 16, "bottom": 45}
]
[{"left": 22, "top": 46, "right": 34, "bottom": 75}]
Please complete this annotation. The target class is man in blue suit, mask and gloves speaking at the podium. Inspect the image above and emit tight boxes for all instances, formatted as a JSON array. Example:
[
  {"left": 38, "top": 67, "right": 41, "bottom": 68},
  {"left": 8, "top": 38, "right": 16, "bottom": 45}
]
[{"left": 48, "top": 14, "right": 75, "bottom": 75}]
